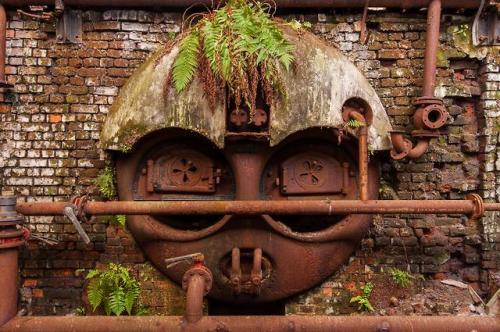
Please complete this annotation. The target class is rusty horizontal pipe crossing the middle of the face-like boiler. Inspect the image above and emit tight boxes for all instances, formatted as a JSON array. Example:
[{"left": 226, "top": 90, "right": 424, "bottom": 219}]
[{"left": 16, "top": 200, "right": 500, "bottom": 216}]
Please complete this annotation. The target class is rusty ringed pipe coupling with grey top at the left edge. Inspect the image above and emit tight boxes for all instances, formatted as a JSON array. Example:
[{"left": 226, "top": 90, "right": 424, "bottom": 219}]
[{"left": 0, "top": 196, "right": 27, "bottom": 249}]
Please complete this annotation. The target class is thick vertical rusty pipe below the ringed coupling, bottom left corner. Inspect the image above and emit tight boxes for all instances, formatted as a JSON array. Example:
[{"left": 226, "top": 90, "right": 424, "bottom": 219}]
[{"left": 0, "top": 248, "right": 19, "bottom": 326}]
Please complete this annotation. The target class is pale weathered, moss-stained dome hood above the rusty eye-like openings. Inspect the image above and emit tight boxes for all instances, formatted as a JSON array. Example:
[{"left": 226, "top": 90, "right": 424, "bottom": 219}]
[{"left": 101, "top": 27, "right": 391, "bottom": 150}]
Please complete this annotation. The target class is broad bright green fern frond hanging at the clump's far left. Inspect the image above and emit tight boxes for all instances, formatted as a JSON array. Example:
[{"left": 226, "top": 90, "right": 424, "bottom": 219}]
[{"left": 172, "top": 29, "right": 200, "bottom": 93}]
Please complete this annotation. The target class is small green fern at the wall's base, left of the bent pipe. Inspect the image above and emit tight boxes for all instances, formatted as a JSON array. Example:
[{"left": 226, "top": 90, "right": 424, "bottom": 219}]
[{"left": 86, "top": 263, "right": 145, "bottom": 316}]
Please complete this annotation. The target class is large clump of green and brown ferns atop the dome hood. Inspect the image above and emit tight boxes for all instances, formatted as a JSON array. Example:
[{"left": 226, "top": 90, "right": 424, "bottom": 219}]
[{"left": 167, "top": 0, "right": 294, "bottom": 117}]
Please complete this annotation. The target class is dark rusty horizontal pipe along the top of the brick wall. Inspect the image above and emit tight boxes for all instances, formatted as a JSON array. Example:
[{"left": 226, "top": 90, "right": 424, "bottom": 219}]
[{"left": 2, "top": 0, "right": 481, "bottom": 8}]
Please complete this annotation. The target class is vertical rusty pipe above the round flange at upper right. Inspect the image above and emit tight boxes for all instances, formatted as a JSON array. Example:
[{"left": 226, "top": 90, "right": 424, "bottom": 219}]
[{"left": 422, "top": 0, "right": 441, "bottom": 97}]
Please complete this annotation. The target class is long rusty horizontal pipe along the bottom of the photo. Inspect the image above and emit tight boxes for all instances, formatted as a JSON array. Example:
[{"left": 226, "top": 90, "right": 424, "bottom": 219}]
[{"left": 0, "top": 315, "right": 500, "bottom": 332}]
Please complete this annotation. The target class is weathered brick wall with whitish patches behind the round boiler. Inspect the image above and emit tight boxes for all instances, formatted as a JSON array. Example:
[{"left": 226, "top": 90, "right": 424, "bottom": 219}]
[{"left": 0, "top": 6, "right": 500, "bottom": 315}]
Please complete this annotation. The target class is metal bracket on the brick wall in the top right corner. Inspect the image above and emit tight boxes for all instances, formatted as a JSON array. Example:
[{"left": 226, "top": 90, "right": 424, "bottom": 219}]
[{"left": 472, "top": 0, "right": 500, "bottom": 46}]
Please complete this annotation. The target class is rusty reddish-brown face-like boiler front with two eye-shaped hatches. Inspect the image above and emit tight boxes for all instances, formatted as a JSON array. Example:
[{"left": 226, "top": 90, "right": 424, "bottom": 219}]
[{"left": 117, "top": 129, "right": 378, "bottom": 303}]
